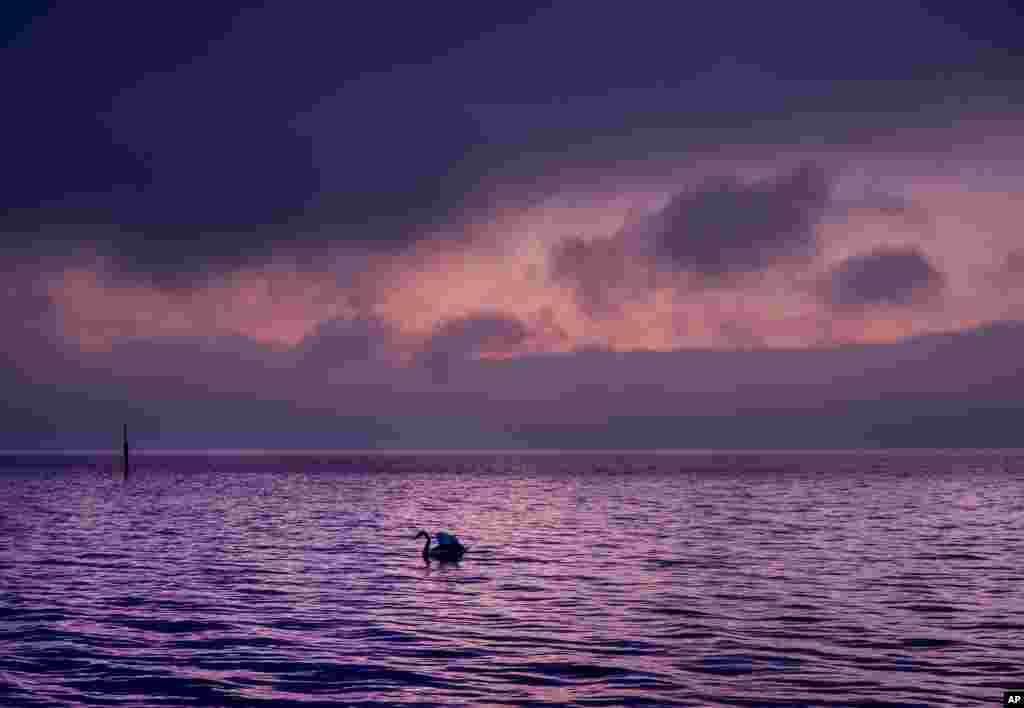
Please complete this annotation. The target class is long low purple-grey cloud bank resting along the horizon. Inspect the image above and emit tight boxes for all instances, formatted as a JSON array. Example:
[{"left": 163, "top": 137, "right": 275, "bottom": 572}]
[{"left": 6, "top": 309, "right": 1024, "bottom": 449}]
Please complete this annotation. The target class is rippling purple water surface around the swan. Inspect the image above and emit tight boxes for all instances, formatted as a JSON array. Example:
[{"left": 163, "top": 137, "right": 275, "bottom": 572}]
[{"left": 0, "top": 453, "right": 1024, "bottom": 706}]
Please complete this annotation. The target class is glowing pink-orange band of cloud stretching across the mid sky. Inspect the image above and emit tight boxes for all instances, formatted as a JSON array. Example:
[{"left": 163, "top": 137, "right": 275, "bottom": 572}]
[{"left": 34, "top": 153, "right": 1024, "bottom": 363}]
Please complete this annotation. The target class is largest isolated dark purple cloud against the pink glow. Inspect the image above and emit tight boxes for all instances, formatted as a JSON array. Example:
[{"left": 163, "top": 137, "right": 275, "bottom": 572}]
[{"left": 643, "top": 165, "right": 830, "bottom": 277}]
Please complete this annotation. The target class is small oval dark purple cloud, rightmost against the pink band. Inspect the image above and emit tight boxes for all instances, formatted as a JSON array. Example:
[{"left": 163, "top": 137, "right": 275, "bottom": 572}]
[{"left": 825, "top": 248, "right": 945, "bottom": 308}]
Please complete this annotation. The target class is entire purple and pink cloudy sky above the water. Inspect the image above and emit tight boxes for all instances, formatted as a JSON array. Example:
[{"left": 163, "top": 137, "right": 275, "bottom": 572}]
[{"left": 0, "top": 0, "right": 1024, "bottom": 449}]
